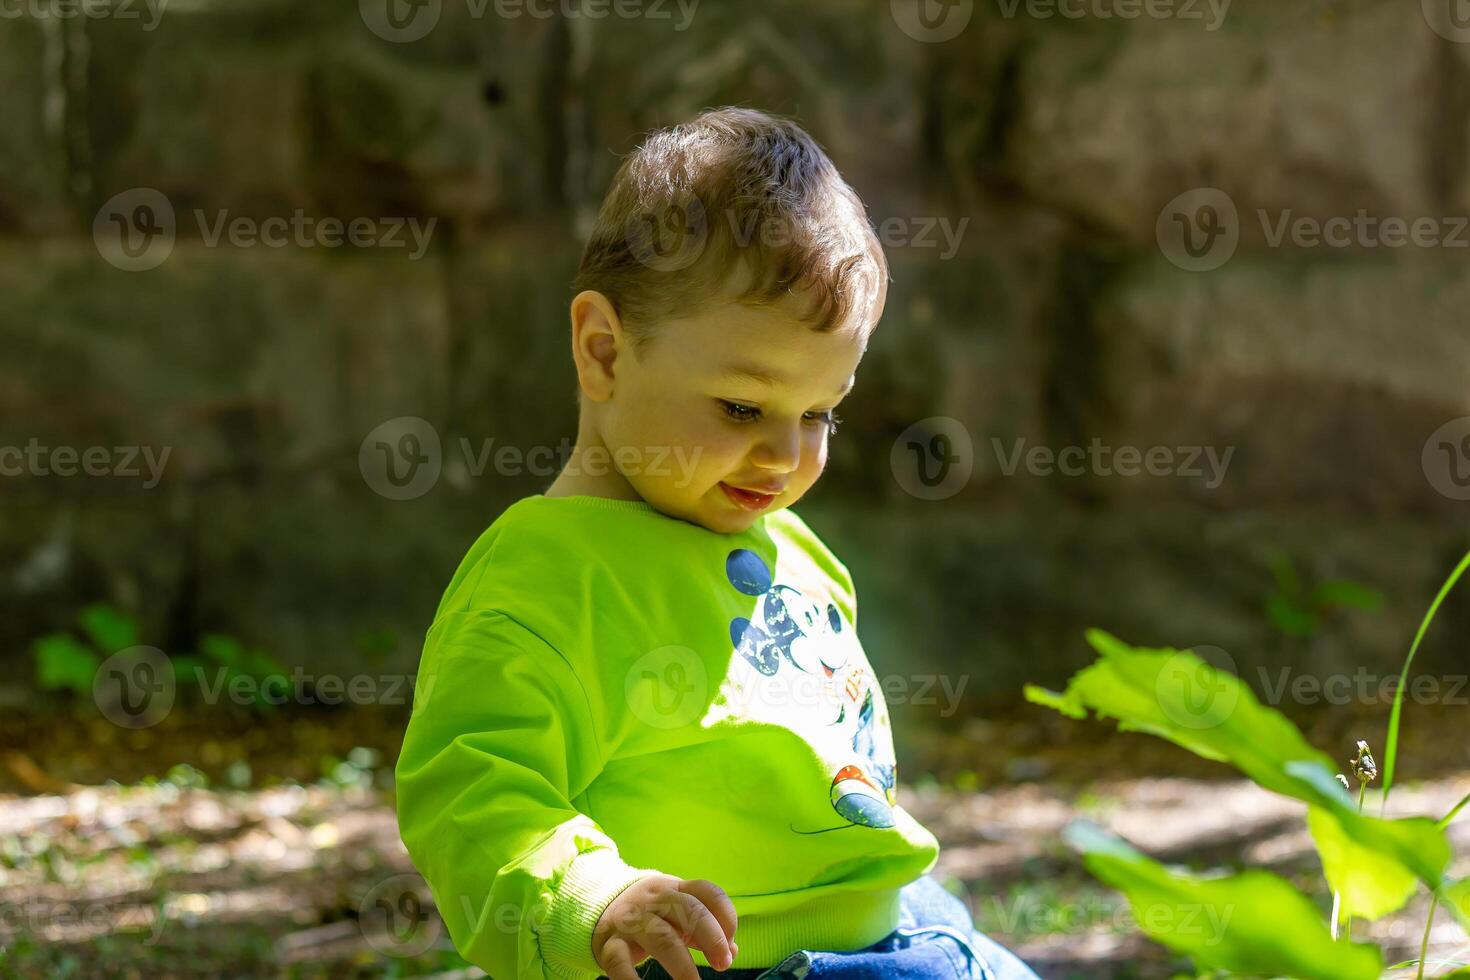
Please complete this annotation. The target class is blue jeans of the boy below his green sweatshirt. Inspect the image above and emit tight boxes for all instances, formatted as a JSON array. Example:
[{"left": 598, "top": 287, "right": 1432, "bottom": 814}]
[{"left": 638, "top": 874, "right": 1039, "bottom": 980}]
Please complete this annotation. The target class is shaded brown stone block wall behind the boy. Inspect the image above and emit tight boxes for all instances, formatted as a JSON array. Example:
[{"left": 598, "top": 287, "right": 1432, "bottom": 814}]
[{"left": 0, "top": 0, "right": 1470, "bottom": 714}]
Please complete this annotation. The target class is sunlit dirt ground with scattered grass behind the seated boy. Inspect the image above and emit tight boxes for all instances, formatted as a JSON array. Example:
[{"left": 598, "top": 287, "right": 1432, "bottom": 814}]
[{"left": 0, "top": 705, "right": 1470, "bottom": 980}]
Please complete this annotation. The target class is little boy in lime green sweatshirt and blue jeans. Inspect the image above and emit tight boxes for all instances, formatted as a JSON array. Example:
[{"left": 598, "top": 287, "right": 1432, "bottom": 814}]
[{"left": 397, "top": 109, "right": 1035, "bottom": 980}]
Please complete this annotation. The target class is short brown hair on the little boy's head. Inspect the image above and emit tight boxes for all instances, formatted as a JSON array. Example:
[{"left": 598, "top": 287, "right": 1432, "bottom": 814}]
[{"left": 573, "top": 107, "right": 888, "bottom": 353}]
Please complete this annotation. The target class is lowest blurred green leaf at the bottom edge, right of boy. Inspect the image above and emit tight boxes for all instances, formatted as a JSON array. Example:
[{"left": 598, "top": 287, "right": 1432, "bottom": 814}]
[{"left": 1064, "top": 821, "right": 1383, "bottom": 980}]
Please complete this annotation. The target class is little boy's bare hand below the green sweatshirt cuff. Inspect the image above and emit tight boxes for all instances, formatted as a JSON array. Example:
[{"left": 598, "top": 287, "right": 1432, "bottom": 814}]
[{"left": 592, "top": 874, "right": 739, "bottom": 980}]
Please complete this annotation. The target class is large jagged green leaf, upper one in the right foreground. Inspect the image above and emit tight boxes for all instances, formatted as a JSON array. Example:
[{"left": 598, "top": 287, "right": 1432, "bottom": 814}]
[{"left": 1026, "top": 629, "right": 1449, "bottom": 889}]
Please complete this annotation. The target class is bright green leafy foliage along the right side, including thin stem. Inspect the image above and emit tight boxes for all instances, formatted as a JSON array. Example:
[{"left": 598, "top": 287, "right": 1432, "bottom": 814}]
[{"left": 1026, "top": 543, "right": 1470, "bottom": 980}]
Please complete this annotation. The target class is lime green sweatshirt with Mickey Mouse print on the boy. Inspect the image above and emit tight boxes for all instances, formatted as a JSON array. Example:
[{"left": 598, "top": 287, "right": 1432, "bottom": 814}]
[{"left": 397, "top": 495, "right": 939, "bottom": 980}]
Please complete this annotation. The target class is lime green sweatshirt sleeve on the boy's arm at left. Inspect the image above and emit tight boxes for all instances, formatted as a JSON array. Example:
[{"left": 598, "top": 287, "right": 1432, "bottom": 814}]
[{"left": 395, "top": 613, "right": 656, "bottom": 980}]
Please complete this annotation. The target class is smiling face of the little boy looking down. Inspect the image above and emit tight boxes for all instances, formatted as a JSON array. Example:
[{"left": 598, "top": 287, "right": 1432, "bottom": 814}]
[{"left": 598, "top": 295, "right": 864, "bottom": 533}]
